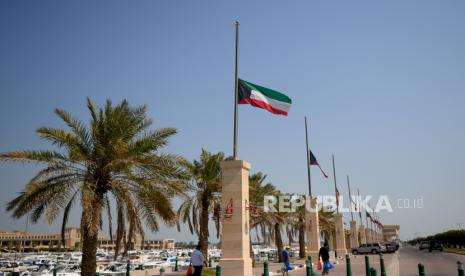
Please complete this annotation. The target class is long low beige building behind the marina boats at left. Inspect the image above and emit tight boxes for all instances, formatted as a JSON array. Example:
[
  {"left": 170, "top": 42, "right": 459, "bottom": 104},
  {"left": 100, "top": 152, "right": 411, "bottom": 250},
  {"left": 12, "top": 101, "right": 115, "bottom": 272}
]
[{"left": 0, "top": 227, "right": 175, "bottom": 252}]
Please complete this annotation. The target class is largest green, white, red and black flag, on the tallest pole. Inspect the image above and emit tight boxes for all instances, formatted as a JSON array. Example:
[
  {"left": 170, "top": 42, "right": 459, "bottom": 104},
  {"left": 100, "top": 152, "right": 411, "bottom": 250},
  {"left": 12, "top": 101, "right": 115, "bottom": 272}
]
[{"left": 238, "top": 79, "right": 292, "bottom": 116}]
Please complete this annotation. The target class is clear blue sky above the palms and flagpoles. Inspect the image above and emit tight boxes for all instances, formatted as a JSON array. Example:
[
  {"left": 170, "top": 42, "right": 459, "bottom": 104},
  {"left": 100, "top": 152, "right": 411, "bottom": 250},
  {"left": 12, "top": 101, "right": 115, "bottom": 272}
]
[{"left": 0, "top": 0, "right": 465, "bottom": 240}]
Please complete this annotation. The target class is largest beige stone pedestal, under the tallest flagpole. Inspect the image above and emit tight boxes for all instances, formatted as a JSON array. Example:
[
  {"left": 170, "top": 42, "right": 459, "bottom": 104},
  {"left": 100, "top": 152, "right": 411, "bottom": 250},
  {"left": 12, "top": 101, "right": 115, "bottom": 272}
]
[{"left": 220, "top": 160, "right": 253, "bottom": 276}]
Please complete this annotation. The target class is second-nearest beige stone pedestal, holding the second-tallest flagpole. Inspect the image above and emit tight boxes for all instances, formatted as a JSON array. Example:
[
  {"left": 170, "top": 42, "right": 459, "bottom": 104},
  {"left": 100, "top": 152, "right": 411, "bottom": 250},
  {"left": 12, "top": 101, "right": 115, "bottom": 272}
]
[{"left": 305, "top": 198, "right": 320, "bottom": 262}]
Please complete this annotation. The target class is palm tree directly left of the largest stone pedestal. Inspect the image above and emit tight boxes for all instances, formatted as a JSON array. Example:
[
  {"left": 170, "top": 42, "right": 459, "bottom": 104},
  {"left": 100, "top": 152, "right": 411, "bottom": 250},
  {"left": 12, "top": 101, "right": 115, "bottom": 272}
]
[{"left": 178, "top": 149, "right": 224, "bottom": 256}]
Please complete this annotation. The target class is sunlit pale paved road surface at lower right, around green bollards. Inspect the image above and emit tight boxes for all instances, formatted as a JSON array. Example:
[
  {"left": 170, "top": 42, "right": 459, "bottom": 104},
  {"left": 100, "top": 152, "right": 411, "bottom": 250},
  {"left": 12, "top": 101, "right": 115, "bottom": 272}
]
[{"left": 280, "top": 246, "right": 465, "bottom": 276}]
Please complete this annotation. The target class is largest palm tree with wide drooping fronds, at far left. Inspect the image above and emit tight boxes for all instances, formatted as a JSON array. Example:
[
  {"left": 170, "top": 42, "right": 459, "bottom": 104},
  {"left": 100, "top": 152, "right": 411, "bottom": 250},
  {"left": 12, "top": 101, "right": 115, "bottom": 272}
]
[{"left": 0, "top": 99, "right": 186, "bottom": 276}]
